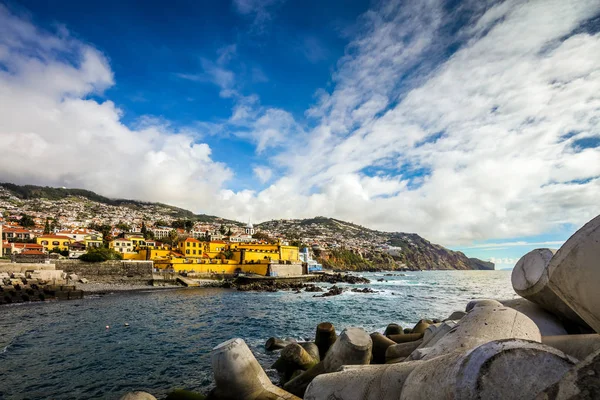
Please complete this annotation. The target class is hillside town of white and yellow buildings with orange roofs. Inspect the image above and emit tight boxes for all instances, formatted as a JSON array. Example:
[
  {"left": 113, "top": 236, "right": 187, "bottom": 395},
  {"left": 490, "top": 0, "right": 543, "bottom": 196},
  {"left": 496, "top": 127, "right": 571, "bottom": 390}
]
[{"left": 0, "top": 184, "right": 493, "bottom": 270}]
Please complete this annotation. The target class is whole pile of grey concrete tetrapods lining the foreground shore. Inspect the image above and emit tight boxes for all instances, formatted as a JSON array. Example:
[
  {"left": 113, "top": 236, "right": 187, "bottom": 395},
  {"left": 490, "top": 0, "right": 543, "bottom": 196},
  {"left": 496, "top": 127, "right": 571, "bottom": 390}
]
[{"left": 119, "top": 216, "right": 600, "bottom": 400}]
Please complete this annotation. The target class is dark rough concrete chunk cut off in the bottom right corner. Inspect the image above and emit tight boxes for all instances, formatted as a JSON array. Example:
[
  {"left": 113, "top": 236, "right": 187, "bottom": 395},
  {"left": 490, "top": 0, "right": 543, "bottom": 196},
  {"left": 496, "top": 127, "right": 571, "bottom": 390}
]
[{"left": 536, "top": 350, "right": 600, "bottom": 400}]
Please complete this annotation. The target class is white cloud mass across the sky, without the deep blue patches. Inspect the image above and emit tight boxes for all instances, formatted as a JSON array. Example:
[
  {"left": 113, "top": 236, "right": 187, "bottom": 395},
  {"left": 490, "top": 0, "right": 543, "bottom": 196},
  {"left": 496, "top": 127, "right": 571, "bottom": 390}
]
[{"left": 0, "top": 0, "right": 600, "bottom": 250}]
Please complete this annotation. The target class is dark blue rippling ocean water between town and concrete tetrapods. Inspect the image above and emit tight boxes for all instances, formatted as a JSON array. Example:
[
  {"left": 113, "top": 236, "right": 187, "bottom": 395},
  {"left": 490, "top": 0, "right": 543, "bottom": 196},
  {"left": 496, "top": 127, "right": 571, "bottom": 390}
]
[{"left": 0, "top": 271, "right": 516, "bottom": 399}]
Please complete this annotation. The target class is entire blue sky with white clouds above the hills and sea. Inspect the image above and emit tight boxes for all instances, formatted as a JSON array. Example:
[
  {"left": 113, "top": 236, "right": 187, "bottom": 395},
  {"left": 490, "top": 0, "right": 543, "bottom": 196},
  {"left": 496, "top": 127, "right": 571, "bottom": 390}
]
[{"left": 0, "top": 0, "right": 600, "bottom": 268}]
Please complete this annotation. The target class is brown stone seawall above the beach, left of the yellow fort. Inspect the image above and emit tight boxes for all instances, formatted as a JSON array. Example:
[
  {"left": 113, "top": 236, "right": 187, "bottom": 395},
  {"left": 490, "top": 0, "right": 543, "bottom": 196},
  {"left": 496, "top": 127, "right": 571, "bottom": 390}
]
[{"left": 55, "top": 260, "right": 154, "bottom": 284}]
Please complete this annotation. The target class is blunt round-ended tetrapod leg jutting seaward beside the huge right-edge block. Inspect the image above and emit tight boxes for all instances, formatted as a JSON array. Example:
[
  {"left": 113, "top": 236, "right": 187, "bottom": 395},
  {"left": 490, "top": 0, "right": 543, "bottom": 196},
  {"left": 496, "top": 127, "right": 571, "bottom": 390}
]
[{"left": 511, "top": 249, "right": 585, "bottom": 325}]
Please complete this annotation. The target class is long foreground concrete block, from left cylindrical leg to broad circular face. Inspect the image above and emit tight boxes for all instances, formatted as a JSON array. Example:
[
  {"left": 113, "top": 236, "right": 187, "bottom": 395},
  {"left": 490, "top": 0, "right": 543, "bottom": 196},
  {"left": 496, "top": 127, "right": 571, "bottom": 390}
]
[{"left": 304, "top": 339, "right": 575, "bottom": 400}]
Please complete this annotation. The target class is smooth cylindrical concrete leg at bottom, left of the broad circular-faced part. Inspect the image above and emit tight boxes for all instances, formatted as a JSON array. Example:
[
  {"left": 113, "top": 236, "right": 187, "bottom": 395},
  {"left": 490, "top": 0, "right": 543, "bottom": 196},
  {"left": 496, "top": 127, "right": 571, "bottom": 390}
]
[{"left": 304, "top": 361, "right": 422, "bottom": 400}]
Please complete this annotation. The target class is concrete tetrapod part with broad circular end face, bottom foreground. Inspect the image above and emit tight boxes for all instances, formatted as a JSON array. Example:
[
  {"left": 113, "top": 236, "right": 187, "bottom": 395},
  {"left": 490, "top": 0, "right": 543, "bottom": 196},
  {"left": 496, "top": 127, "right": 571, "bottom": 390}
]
[{"left": 396, "top": 339, "right": 576, "bottom": 400}]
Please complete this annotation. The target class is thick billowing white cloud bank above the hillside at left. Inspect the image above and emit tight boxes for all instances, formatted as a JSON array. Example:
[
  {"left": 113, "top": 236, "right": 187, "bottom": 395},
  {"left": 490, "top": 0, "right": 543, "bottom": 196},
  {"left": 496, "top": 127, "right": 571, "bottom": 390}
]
[{"left": 0, "top": 6, "right": 232, "bottom": 208}]
